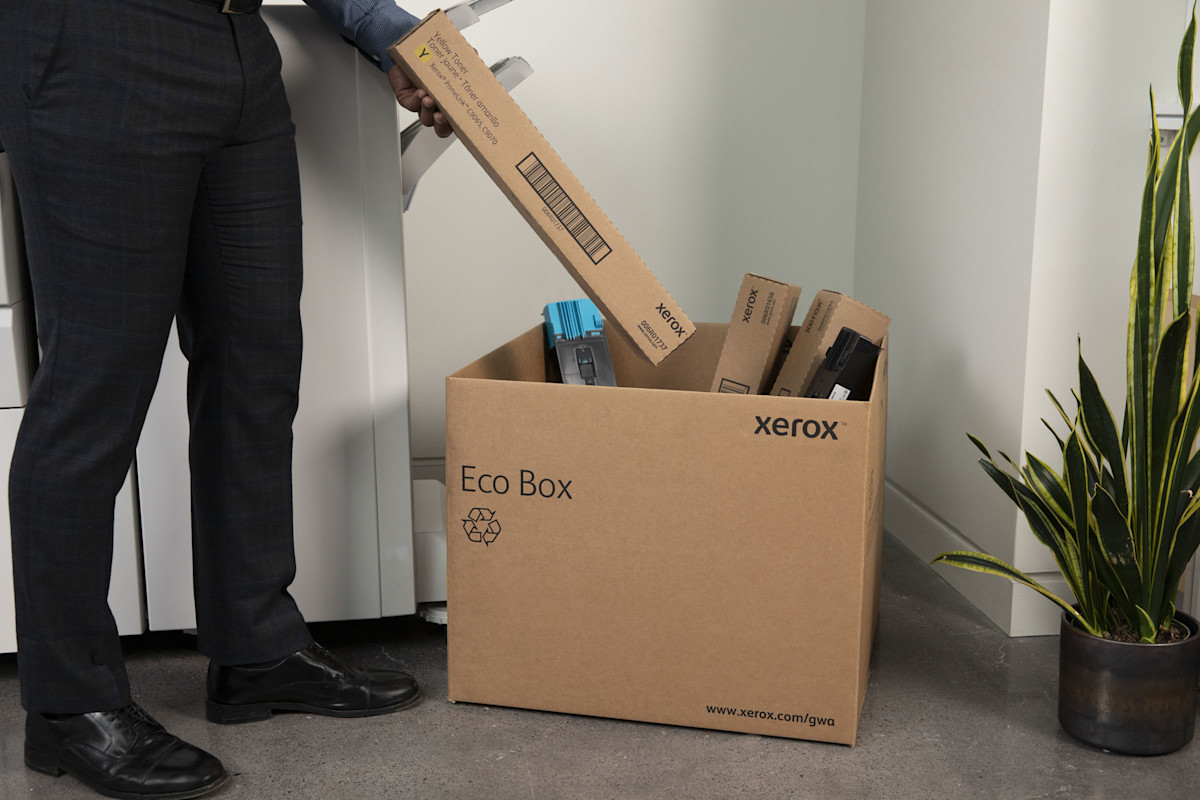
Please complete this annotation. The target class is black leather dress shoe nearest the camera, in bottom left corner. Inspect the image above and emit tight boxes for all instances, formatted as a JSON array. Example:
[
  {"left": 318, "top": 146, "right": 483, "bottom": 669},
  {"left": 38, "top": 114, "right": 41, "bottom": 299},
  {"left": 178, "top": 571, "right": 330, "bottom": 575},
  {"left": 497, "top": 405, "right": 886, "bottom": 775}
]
[{"left": 25, "top": 703, "right": 227, "bottom": 800}]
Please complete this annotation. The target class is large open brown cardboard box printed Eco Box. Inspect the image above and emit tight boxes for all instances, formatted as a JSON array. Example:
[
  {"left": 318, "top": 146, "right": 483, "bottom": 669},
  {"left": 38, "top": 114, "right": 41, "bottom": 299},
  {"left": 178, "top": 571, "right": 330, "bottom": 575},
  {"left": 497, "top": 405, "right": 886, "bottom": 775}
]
[{"left": 446, "top": 324, "right": 887, "bottom": 744}]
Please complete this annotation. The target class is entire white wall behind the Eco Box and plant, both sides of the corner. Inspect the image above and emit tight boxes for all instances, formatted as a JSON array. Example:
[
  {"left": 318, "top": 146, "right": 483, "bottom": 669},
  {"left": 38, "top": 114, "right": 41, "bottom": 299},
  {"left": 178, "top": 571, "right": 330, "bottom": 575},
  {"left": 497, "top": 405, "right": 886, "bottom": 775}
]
[{"left": 404, "top": 0, "right": 1186, "bottom": 634}]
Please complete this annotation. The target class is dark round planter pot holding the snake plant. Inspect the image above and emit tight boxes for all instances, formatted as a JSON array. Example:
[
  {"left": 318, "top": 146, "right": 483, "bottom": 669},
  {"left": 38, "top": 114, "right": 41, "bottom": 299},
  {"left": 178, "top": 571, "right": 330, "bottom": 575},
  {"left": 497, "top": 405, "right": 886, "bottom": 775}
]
[{"left": 1058, "top": 613, "right": 1200, "bottom": 756}]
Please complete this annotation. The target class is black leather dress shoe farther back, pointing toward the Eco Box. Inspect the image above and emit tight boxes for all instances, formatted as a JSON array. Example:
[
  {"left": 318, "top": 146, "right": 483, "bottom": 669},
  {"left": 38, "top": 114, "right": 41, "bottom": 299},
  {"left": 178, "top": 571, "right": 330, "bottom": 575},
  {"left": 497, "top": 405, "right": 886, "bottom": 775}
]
[{"left": 206, "top": 644, "right": 421, "bottom": 724}]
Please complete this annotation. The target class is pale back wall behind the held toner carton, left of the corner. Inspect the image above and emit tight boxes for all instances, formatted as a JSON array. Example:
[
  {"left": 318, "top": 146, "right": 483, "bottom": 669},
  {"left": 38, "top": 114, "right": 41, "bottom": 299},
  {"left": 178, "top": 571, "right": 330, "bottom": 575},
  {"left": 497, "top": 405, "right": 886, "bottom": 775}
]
[{"left": 403, "top": 0, "right": 866, "bottom": 462}]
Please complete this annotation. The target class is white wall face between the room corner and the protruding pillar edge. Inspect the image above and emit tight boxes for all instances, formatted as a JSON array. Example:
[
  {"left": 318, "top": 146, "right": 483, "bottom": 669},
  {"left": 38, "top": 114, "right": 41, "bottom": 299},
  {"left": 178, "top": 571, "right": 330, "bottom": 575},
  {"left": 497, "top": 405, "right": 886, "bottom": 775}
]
[{"left": 854, "top": 0, "right": 1049, "bottom": 625}]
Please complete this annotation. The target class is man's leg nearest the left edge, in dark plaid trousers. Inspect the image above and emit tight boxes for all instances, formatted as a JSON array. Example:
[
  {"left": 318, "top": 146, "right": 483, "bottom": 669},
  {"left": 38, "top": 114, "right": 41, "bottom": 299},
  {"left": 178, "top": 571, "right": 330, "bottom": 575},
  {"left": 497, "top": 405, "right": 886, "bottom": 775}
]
[{"left": 0, "top": 0, "right": 226, "bottom": 714}]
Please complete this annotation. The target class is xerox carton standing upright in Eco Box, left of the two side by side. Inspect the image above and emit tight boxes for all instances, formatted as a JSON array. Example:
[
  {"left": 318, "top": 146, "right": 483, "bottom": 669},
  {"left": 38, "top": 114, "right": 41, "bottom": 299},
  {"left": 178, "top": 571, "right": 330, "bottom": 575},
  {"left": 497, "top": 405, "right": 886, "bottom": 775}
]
[{"left": 709, "top": 272, "right": 800, "bottom": 395}]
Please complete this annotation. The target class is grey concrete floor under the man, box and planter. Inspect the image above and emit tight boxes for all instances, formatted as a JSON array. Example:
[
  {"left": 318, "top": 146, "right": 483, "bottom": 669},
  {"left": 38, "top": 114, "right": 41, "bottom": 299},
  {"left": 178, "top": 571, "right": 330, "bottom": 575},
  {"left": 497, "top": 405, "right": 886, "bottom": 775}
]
[{"left": 0, "top": 537, "right": 1200, "bottom": 800}]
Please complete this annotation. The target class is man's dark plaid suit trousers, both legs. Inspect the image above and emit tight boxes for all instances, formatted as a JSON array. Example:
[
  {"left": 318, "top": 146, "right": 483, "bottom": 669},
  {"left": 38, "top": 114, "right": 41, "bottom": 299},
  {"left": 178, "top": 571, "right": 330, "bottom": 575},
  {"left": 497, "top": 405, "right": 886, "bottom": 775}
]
[{"left": 0, "top": 0, "right": 311, "bottom": 712}]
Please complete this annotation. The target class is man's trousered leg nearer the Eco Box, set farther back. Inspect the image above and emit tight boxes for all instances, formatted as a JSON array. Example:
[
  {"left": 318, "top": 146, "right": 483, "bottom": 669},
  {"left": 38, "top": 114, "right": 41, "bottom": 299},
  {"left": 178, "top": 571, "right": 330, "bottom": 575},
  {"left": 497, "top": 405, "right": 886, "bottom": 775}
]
[{"left": 179, "top": 14, "right": 312, "bottom": 664}]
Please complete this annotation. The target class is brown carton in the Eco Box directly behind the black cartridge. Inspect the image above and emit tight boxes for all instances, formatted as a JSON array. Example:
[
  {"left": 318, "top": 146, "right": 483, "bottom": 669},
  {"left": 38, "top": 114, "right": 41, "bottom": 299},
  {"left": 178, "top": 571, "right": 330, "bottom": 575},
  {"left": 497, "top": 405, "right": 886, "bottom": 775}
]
[{"left": 770, "top": 289, "right": 892, "bottom": 397}]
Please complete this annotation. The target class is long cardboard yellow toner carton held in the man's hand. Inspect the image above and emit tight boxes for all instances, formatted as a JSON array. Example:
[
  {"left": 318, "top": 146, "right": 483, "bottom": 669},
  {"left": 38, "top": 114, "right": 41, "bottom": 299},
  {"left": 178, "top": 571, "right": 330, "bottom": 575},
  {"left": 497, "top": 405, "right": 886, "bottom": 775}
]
[{"left": 388, "top": 11, "right": 696, "bottom": 363}]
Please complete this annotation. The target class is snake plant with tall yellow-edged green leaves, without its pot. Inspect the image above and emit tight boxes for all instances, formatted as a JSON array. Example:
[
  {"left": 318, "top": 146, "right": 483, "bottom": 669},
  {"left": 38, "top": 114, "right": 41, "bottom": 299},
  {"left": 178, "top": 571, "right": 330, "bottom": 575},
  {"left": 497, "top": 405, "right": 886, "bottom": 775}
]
[{"left": 934, "top": 11, "right": 1200, "bottom": 642}]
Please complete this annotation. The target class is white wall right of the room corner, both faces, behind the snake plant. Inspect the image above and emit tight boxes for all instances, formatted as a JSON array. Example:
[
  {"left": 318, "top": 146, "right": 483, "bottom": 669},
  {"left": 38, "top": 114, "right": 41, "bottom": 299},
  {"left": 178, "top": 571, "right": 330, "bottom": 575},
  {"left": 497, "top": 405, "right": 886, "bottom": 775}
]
[{"left": 854, "top": 0, "right": 1184, "bottom": 634}]
